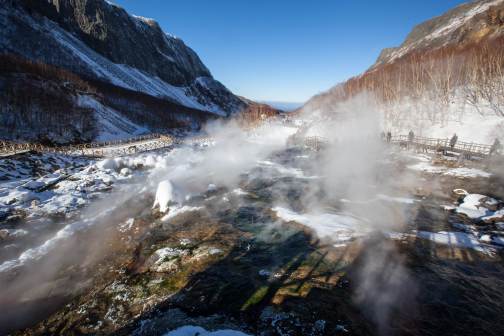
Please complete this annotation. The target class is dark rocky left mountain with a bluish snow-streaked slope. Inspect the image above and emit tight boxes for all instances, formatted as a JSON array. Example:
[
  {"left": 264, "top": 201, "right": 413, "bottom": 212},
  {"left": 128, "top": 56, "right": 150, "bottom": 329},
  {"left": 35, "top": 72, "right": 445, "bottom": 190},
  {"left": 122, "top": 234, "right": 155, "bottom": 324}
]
[{"left": 0, "top": 0, "right": 246, "bottom": 143}]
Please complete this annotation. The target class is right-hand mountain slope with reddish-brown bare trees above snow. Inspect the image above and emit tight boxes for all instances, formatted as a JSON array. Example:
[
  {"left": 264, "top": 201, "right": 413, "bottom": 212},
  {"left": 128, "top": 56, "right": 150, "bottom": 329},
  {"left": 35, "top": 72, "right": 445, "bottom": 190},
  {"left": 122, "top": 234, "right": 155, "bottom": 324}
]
[{"left": 299, "top": 0, "right": 504, "bottom": 143}]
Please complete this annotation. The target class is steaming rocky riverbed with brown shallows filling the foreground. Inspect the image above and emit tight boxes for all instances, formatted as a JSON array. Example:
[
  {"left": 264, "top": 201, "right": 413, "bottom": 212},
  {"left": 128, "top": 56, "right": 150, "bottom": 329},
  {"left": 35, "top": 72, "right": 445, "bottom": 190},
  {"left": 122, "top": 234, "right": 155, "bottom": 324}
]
[{"left": 0, "top": 135, "right": 504, "bottom": 335}]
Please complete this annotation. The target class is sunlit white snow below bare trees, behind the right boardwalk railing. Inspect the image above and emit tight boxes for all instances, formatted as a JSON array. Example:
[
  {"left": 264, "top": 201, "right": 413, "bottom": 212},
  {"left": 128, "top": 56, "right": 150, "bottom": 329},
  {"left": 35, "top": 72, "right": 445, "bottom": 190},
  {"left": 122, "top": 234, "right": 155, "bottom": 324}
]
[{"left": 302, "top": 93, "right": 504, "bottom": 145}]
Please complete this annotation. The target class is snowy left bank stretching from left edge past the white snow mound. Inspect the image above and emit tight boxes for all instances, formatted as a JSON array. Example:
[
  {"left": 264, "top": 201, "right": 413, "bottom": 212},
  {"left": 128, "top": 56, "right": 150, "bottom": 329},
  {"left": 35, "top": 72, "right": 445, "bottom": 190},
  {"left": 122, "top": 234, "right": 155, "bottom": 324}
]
[{"left": 0, "top": 122, "right": 298, "bottom": 271}]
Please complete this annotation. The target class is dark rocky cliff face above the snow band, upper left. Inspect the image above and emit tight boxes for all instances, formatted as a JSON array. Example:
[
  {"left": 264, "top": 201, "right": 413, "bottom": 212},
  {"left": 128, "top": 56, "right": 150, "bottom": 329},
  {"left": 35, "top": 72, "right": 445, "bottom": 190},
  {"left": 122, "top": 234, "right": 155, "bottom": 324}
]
[{"left": 17, "top": 0, "right": 211, "bottom": 86}]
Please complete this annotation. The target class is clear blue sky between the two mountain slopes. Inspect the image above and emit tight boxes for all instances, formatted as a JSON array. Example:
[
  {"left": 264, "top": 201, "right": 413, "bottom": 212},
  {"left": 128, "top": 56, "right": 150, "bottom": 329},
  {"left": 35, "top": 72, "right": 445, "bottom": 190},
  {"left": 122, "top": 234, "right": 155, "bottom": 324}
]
[{"left": 113, "top": 0, "right": 466, "bottom": 102}]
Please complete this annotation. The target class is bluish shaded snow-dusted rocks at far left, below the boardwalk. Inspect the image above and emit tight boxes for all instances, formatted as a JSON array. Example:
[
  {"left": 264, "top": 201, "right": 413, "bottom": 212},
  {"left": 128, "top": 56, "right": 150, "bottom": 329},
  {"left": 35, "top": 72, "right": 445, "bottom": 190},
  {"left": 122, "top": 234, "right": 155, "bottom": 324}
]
[{"left": 0, "top": 153, "right": 179, "bottom": 271}]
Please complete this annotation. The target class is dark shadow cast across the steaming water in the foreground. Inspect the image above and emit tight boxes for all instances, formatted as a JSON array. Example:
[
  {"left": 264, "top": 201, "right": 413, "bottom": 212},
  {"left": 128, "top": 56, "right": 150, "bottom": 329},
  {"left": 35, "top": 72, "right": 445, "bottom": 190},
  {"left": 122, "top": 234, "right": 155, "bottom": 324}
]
[{"left": 111, "top": 223, "right": 504, "bottom": 336}]
